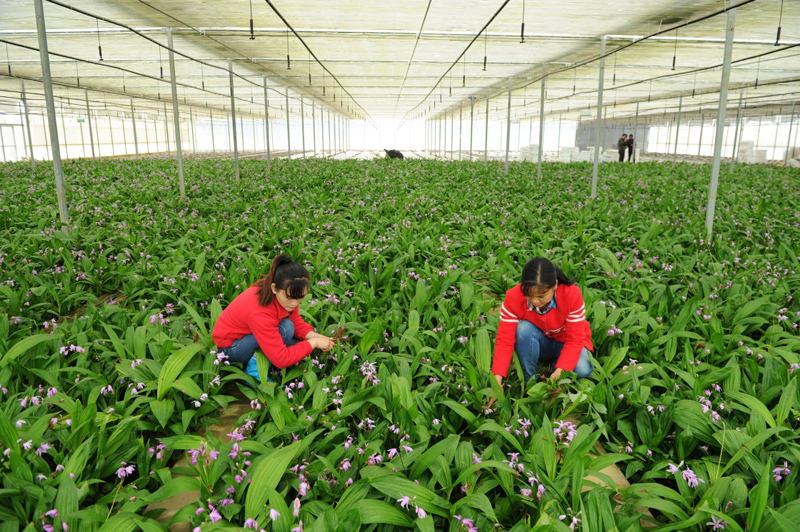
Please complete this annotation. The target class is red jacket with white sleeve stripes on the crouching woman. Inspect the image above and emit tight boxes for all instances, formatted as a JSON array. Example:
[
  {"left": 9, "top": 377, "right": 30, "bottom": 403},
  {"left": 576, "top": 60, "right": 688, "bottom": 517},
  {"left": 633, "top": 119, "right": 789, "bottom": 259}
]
[{"left": 492, "top": 284, "right": 594, "bottom": 377}]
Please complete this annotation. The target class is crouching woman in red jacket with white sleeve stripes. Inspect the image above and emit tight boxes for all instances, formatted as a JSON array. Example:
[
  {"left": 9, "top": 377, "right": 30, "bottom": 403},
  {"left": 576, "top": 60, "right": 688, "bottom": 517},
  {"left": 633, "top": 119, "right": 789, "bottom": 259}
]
[{"left": 492, "top": 258, "right": 594, "bottom": 392}]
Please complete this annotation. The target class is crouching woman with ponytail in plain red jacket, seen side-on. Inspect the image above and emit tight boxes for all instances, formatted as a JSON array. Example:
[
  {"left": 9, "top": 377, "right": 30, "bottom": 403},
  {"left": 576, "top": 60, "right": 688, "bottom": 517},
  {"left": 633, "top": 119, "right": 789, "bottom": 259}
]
[{"left": 211, "top": 254, "right": 333, "bottom": 380}]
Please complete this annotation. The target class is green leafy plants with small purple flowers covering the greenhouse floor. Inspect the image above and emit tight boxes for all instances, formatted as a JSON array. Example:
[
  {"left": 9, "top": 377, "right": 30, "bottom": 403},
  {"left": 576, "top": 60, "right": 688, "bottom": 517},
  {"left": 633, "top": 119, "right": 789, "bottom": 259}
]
[{"left": 0, "top": 156, "right": 800, "bottom": 532}]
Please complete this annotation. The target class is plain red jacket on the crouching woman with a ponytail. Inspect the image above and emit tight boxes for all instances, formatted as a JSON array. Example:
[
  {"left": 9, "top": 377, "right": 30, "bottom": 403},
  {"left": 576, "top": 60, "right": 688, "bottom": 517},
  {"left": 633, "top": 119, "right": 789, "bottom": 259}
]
[{"left": 211, "top": 286, "right": 314, "bottom": 368}]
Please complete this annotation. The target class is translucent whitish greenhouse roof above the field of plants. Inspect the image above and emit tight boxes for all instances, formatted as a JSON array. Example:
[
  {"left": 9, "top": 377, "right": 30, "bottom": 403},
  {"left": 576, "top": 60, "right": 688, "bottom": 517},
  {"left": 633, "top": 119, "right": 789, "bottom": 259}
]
[{"left": 0, "top": 0, "right": 800, "bottom": 121}]
